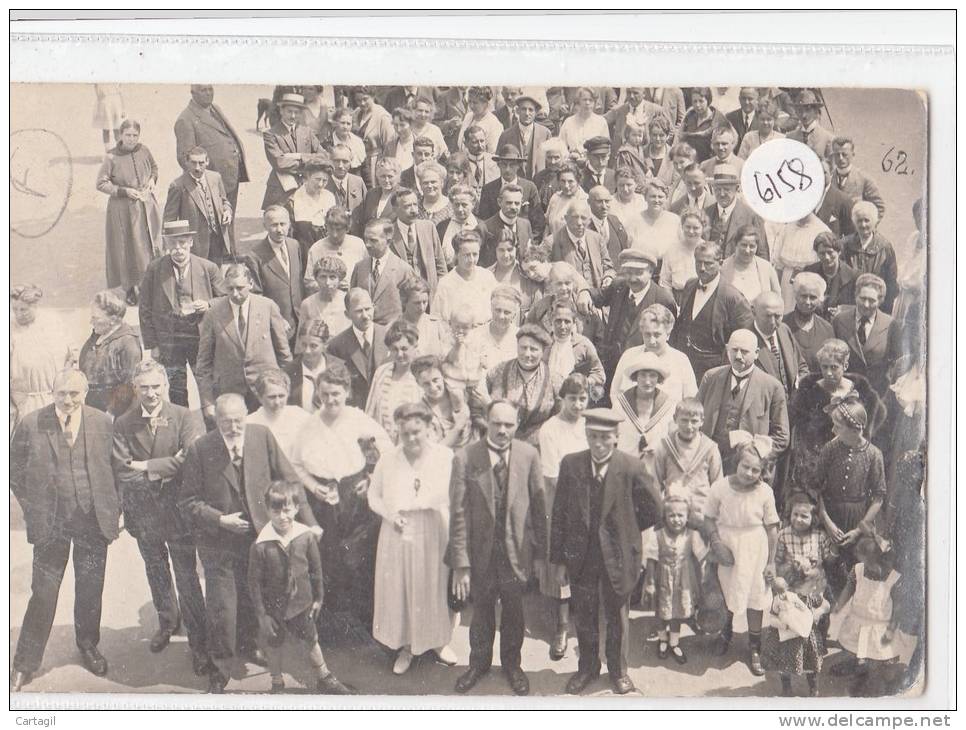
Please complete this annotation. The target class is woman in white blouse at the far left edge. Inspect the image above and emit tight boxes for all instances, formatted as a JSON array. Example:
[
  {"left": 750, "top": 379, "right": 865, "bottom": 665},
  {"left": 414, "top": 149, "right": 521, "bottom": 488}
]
[{"left": 10, "top": 284, "right": 77, "bottom": 420}]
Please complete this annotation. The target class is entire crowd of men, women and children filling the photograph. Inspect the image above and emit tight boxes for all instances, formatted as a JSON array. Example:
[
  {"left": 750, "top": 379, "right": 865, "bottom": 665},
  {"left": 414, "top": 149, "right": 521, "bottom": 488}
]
[{"left": 11, "top": 85, "right": 926, "bottom": 695}]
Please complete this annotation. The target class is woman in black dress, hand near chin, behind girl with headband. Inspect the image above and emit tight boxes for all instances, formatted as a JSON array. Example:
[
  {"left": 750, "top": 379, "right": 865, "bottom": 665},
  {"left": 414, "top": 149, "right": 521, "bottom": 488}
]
[{"left": 787, "top": 338, "right": 886, "bottom": 494}]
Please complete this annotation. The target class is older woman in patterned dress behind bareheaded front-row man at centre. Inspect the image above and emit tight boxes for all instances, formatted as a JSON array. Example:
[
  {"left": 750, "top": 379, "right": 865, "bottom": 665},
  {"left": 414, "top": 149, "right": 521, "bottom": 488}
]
[{"left": 486, "top": 323, "right": 561, "bottom": 446}]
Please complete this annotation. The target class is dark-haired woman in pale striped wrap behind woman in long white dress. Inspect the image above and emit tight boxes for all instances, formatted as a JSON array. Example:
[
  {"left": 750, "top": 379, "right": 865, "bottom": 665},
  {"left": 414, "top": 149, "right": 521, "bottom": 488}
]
[{"left": 366, "top": 319, "right": 423, "bottom": 442}]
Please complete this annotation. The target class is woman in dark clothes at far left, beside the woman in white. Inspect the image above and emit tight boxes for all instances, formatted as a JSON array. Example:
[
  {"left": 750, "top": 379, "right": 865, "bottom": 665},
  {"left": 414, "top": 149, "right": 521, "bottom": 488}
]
[{"left": 78, "top": 289, "right": 141, "bottom": 418}]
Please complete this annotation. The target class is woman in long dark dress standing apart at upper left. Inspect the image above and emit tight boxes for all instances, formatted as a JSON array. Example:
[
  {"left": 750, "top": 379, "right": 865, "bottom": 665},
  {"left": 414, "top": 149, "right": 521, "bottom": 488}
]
[{"left": 97, "top": 119, "right": 161, "bottom": 304}]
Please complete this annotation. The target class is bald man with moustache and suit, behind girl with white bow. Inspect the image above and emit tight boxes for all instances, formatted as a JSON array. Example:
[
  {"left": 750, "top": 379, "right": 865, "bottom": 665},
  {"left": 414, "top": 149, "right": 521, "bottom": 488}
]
[{"left": 698, "top": 329, "right": 789, "bottom": 474}]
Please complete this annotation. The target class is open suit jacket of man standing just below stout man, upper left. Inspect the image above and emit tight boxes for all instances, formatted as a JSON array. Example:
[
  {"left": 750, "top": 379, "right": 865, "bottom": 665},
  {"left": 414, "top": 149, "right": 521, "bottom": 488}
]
[{"left": 164, "top": 170, "right": 234, "bottom": 263}]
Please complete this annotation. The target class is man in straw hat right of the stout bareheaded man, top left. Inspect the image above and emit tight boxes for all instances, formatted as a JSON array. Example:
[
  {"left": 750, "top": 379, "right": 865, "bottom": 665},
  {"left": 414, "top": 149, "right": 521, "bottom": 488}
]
[{"left": 262, "top": 94, "right": 322, "bottom": 210}]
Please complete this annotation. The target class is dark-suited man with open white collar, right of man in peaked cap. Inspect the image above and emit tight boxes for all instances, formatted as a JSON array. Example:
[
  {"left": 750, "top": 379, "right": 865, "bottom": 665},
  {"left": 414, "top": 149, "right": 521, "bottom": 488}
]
[{"left": 670, "top": 242, "right": 755, "bottom": 383}]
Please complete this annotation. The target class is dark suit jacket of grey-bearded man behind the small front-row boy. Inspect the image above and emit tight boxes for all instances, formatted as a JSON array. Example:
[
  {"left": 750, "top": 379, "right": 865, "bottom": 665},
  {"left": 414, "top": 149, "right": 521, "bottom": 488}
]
[{"left": 178, "top": 423, "right": 317, "bottom": 550}]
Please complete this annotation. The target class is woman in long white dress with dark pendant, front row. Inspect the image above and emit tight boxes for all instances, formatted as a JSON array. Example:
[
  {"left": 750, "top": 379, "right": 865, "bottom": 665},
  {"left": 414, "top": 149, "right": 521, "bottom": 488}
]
[{"left": 368, "top": 403, "right": 456, "bottom": 674}]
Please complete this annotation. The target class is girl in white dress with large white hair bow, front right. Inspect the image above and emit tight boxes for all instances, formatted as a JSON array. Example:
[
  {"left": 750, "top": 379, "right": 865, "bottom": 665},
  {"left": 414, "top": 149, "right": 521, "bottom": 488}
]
[{"left": 704, "top": 431, "right": 779, "bottom": 677}]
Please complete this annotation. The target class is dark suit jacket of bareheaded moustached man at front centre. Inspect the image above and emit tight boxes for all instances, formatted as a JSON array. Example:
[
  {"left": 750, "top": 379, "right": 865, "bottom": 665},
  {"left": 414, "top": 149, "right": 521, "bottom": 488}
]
[{"left": 445, "top": 439, "right": 547, "bottom": 591}]
